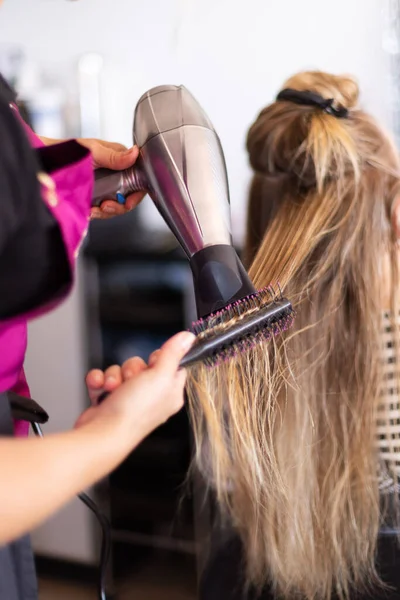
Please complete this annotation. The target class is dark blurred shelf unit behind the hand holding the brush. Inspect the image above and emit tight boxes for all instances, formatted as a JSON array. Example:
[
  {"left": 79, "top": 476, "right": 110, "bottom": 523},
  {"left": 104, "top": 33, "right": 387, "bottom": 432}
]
[{"left": 85, "top": 229, "right": 198, "bottom": 568}]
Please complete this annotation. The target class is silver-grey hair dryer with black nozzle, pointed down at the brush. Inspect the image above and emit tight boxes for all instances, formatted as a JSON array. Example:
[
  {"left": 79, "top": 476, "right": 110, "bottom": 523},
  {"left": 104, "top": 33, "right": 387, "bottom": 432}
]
[{"left": 93, "top": 85, "right": 256, "bottom": 317}]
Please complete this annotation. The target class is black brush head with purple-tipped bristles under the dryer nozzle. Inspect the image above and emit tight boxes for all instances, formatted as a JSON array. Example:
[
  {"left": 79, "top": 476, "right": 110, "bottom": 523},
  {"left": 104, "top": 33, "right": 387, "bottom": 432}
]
[{"left": 180, "top": 287, "right": 294, "bottom": 367}]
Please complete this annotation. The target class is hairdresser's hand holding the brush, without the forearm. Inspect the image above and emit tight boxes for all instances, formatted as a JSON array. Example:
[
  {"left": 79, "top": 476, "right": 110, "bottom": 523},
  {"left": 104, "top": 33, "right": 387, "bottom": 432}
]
[{"left": 76, "top": 332, "right": 195, "bottom": 451}]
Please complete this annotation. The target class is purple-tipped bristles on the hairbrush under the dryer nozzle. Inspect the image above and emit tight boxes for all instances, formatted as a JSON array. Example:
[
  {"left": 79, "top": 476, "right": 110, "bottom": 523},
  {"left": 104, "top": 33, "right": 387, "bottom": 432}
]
[{"left": 187, "top": 285, "right": 294, "bottom": 367}]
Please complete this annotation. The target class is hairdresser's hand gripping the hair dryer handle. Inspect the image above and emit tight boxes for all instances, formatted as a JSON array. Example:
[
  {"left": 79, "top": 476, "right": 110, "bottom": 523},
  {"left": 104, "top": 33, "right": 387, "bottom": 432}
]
[{"left": 40, "top": 137, "right": 145, "bottom": 219}]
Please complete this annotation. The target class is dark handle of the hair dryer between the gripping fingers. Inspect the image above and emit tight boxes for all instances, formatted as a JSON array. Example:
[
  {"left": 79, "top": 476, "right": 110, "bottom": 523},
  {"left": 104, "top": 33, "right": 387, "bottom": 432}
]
[{"left": 92, "top": 165, "right": 148, "bottom": 206}]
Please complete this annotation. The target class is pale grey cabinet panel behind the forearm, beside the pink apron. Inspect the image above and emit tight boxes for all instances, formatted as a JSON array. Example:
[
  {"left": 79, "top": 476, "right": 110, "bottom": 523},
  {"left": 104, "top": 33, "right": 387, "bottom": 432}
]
[{"left": 26, "top": 268, "right": 98, "bottom": 563}]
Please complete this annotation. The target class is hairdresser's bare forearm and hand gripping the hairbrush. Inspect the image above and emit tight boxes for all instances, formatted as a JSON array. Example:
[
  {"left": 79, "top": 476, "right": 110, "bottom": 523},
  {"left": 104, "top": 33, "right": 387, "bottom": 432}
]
[{"left": 0, "top": 333, "right": 194, "bottom": 545}]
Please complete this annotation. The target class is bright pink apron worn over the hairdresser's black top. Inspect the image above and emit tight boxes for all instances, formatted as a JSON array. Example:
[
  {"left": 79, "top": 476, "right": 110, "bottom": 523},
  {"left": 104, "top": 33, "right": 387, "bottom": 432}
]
[{"left": 0, "top": 107, "right": 93, "bottom": 436}]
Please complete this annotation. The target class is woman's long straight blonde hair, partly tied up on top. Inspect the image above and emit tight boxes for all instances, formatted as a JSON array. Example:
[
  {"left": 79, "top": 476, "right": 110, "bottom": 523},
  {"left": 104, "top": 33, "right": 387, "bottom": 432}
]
[{"left": 188, "top": 72, "right": 400, "bottom": 600}]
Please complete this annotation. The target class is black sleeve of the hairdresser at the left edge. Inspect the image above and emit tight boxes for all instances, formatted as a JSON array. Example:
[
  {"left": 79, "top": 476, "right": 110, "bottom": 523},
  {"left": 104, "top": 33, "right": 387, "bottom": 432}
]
[{"left": 0, "top": 98, "right": 71, "bottom": 319}]
